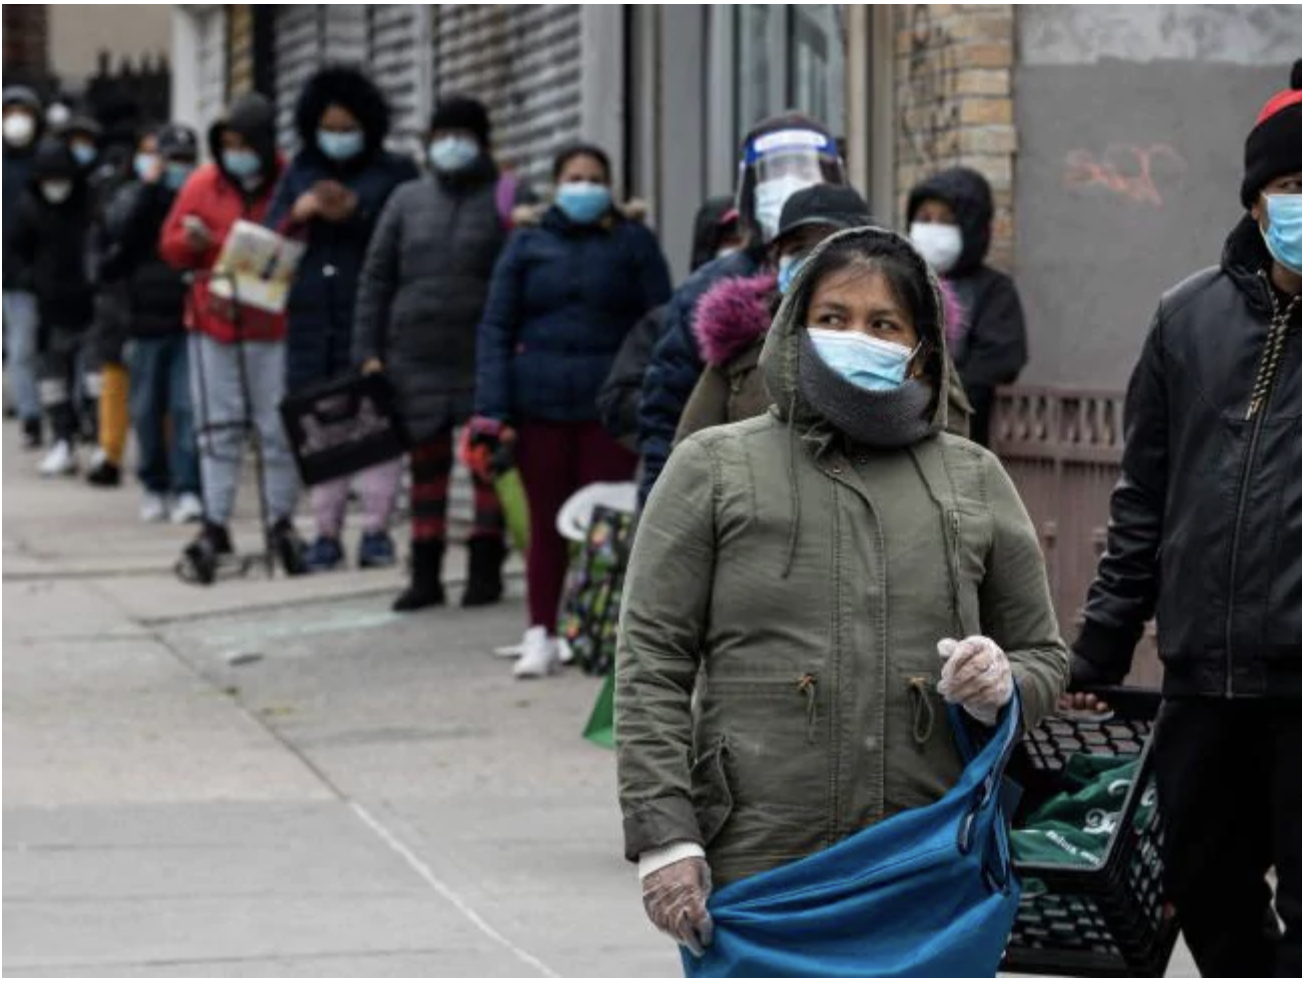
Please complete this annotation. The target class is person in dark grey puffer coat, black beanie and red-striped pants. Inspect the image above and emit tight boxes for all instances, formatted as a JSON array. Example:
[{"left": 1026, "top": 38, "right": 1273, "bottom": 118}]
[{"left": 352, "top": 95, "right": 533, "bottom": 612}]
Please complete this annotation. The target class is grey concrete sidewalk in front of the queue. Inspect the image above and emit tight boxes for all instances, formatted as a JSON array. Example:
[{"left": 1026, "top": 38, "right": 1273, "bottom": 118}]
[{"left": 3, "top": 426, "right": 1191, "bottom": 977}]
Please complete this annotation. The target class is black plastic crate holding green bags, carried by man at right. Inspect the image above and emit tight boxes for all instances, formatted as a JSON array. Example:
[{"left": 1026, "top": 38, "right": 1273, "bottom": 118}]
[{"left": 1001, "top": 690, "right": 1178, "bottom": 978}]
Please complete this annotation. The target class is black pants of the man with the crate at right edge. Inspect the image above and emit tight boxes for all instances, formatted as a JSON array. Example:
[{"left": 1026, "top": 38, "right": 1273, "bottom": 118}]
[{"left": 1154, "top": 699, "right": 1300, "bottom": 978}]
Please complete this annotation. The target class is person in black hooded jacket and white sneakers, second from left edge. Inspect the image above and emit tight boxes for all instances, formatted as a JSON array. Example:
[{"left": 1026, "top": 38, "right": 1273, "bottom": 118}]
[{"left": 10, "top": 138, "right": 94, "bottom": 477}]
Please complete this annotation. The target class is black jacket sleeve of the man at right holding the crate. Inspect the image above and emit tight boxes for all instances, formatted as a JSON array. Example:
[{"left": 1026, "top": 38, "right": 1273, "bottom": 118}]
[{"left": 1073, "top": 305, "right": 1168, "bottom": 683}]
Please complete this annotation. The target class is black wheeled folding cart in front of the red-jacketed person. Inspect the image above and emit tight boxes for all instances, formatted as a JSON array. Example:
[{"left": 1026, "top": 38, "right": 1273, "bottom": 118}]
[{"left": 173, "top": 270, "right": 276, "bottom": 586}]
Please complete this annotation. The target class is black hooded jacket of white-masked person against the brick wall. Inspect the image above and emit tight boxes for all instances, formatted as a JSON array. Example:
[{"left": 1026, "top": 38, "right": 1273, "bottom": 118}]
[{"left": 906, "top": 167, "right": 1028, "bottom": 446}]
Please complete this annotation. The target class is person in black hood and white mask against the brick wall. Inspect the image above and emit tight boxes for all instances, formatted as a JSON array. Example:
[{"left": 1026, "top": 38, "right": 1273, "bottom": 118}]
[{"left": 906, "top": 167, "right": 1028, "bottom": 446}]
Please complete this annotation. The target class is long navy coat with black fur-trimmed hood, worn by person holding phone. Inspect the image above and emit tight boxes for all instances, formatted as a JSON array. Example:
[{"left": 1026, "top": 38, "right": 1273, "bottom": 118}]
[{"left": 263, "top": 68, "right": 419, "bottom": 391}]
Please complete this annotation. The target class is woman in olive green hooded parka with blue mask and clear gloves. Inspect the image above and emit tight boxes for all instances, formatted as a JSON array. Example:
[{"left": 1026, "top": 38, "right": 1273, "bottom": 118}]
[{"left": 615, "top": 228, "right": 1068, "bottom": 951}]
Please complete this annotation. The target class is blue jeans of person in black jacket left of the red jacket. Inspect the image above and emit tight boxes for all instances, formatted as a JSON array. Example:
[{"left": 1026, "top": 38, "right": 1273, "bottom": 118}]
[{"left": 126, "top": 333, "right": 200, "bottom": 494}]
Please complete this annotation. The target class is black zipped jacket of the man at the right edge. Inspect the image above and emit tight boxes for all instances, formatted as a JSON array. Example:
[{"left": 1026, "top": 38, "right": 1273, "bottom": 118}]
[{"left": 1074, "top": 218, "right": 1300, "bottom": 699}]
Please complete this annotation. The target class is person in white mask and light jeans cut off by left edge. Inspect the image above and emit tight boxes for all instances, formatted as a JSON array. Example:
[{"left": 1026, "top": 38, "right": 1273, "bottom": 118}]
[{"left": 0, "top": 85, "right": 44, "bottom": 450}]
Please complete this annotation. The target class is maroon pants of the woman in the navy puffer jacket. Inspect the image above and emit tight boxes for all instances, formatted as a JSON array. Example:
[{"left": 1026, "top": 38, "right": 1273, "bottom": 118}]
[{"left": 516, "top": 421, "right": 638, "bottom": 623}]
